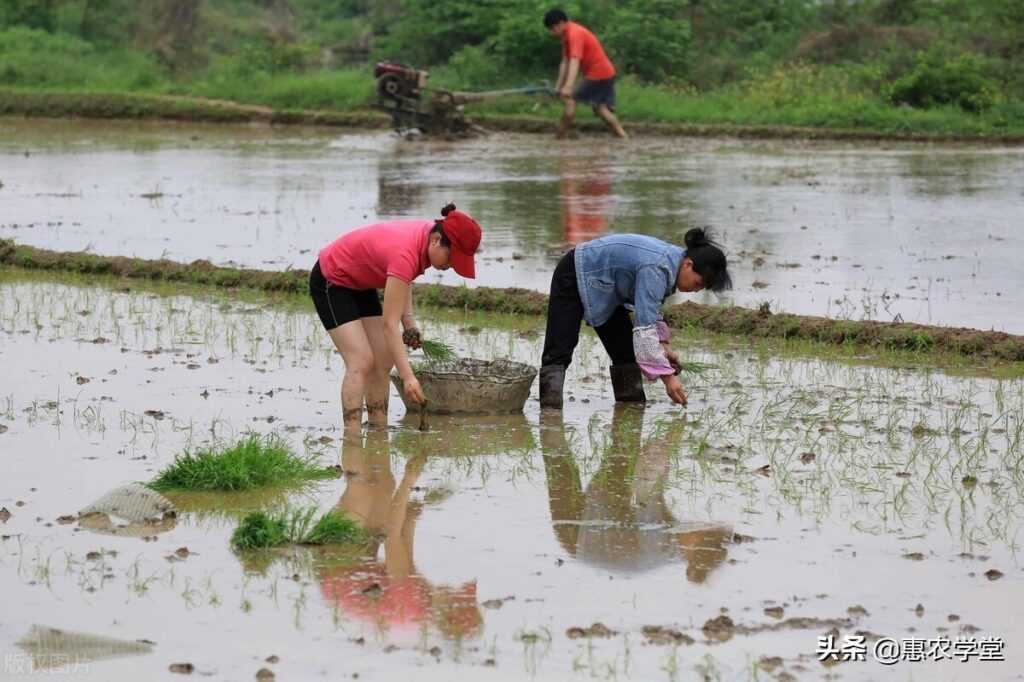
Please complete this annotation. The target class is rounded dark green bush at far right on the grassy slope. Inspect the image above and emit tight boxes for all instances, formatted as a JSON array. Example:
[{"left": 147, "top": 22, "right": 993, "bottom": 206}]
[{"left": 889, "top": 46, "right": 998, "bottom": 113}]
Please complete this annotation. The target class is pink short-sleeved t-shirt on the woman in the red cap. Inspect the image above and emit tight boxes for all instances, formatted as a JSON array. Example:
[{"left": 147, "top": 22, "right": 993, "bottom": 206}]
[{"left": 319, "top": 220, "right": 434, "bottom": 290}]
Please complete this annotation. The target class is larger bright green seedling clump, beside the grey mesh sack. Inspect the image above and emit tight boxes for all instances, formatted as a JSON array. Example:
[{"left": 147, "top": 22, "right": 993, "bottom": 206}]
[{"left": 148, "top": 433, "right": 335, "bottom": 491}]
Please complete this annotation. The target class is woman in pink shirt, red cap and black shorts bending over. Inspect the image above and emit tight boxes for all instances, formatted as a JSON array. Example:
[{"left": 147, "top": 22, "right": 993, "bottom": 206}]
[{"left": 309, "top": 204, "right": 480, "bottom": 427}]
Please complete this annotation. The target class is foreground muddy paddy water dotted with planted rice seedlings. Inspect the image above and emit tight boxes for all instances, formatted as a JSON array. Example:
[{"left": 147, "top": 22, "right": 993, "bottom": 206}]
[{"left": 0, "top": 274, "right": 1024, "bottom": 680}]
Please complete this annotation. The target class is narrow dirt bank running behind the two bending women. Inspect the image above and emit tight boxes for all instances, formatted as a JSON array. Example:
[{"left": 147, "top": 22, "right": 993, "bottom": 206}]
[{"left": 0, "top": 240, "right": 1024, "bottom": 361}]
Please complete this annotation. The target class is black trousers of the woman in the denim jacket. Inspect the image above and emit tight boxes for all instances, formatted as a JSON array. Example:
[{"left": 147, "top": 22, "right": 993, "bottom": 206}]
[{"left": 541, "top": 249, "right": 637, "bottom": 367}]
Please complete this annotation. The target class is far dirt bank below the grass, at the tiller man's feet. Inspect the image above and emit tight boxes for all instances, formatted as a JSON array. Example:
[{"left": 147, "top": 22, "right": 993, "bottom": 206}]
[{"left": 0, "top": 88, "right": 1024, "bottom": 145}]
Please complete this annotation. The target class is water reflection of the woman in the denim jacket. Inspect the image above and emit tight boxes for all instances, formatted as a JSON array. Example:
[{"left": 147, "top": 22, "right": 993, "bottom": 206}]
[{"left": 541, "top": 404, "right": 732, "bottom": 583}]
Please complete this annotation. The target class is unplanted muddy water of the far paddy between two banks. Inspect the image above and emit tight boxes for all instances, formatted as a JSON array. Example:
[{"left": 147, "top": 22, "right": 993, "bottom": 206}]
[{"left": 0, "top": 120, "right": 1024, "bottom": 333}]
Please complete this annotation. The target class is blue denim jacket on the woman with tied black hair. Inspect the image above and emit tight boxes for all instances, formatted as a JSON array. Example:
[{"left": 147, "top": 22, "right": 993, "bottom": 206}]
[{"left": 575, "top": 235, "right": 686, "bottom": 329}]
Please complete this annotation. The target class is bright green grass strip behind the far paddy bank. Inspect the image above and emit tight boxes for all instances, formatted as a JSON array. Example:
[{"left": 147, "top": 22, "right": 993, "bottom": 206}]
[{"left": 0, "top": 29, "right": 1024, "bottom": 137}]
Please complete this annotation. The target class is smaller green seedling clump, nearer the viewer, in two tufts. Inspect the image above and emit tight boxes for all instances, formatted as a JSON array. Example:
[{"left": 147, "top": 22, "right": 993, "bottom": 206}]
[{"left": 231, "top": 508, "right": 370, "bottom": 549}]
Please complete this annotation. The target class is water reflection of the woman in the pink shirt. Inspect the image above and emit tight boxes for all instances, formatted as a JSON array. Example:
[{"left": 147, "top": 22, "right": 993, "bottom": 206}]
[{"left": 319, "top": 429, "right": 482, "bottom": 641}]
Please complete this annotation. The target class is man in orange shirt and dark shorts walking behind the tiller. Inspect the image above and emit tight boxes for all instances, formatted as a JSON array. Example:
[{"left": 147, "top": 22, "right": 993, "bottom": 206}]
[{"left": 544, "top": 9, "right": 629, "bottom": 138}]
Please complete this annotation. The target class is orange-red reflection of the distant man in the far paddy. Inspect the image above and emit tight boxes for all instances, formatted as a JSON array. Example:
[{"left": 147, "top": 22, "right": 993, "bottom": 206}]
[{"left": 560, "top": 154, "right": 614, "bottom": 246}]
